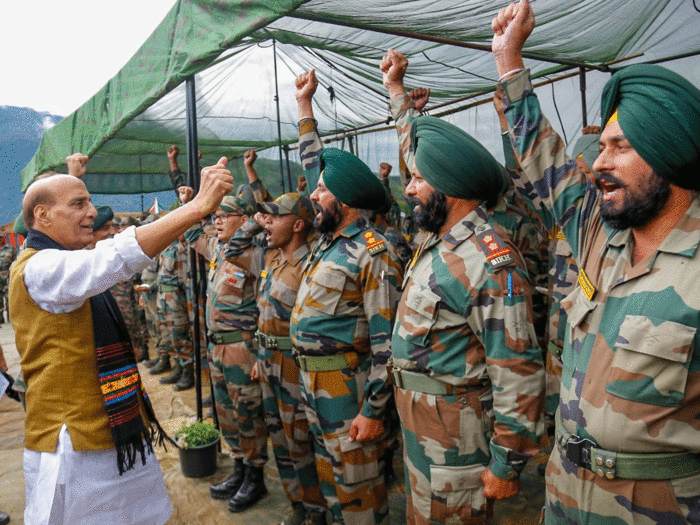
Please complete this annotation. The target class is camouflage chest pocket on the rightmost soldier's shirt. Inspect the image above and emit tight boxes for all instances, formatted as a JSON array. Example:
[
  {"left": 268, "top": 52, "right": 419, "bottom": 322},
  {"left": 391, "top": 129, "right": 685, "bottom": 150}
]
[{"left": 605, "top": 315, "right": 696, "bottom": 406}]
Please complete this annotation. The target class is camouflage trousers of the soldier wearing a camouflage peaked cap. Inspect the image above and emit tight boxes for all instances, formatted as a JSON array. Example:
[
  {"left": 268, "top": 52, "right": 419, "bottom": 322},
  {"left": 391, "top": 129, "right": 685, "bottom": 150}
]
[{"left": 258, "top": 347, "right": 326, "bottom": 511}]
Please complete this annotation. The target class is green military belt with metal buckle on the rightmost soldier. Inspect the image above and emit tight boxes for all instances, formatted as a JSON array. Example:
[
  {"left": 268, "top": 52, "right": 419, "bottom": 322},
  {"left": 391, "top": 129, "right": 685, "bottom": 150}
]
[{"left": 555, "top": 410, "right": 700, "bottom": 480}]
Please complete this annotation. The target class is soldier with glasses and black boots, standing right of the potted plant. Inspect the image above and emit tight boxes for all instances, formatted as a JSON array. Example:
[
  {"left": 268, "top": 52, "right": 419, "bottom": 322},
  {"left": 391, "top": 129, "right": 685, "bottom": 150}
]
[{"left": 185, "top": 190, "right": 267, "bottom": 512}]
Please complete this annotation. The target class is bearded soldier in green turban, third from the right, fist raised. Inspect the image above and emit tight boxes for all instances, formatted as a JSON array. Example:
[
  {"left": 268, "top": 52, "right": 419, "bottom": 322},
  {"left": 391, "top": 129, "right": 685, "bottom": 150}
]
[{"left": 290, "top": 73, "right": 403, "bottom": 525}]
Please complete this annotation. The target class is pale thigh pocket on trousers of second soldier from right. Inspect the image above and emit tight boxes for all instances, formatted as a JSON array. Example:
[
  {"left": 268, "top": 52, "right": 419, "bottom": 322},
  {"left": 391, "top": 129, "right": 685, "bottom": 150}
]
[{"left": 430, "top": 465, "right": 486, "bottom": 523}]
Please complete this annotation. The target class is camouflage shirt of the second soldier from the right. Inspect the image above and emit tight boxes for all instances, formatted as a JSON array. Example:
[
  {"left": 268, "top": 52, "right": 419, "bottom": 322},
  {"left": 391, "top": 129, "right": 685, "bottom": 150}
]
[{"left": 392, "top": 205, "right": 544, "bottom": 479}]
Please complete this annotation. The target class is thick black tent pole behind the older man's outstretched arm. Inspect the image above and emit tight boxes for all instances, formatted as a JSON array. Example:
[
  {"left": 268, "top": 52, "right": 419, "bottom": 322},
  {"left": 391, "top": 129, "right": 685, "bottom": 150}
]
[{"left": 185, "top": 75, "right": 202, "bottom": 421}]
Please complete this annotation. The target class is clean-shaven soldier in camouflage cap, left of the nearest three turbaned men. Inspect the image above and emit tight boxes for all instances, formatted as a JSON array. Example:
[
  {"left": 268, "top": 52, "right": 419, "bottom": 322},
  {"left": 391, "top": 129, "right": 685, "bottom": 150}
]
[{"left": 226, "top": 150, "right": 326, "bottom": 525}]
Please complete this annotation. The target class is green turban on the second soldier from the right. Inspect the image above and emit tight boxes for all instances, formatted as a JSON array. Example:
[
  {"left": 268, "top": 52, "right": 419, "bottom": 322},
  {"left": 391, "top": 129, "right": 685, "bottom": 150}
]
[{"left": 411, "top": 117, "right": 507, "bottom": 200}]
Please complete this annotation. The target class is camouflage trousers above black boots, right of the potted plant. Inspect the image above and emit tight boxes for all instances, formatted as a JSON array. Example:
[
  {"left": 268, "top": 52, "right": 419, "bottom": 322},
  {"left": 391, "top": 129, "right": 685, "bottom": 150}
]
[{"left": 207, "top": 332, "right": 267, "bottom": 467}]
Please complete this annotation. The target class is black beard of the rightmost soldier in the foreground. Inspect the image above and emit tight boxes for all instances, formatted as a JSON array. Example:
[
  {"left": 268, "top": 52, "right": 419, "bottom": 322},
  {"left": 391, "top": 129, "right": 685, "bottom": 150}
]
[{"left": 598, "top": 171, "right": 671, "bottom": 230}]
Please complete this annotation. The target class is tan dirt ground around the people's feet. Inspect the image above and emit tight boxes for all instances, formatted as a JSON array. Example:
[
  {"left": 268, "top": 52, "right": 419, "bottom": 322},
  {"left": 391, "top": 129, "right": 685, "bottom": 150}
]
[{"left": 0, "top": 323, "right": 546, "bottom": 525}]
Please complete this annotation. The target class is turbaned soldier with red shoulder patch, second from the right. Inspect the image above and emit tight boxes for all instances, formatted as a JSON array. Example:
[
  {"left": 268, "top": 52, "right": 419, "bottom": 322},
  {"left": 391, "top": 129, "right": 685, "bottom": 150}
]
[{"left": 380, "top": 50, "right": 544, "bottom": 524}]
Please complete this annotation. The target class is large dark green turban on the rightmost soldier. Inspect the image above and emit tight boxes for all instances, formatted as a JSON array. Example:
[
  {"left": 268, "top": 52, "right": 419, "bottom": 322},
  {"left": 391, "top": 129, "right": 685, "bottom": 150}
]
[{"left": 600, "top": 64, "right": 700, "bottom": 190}]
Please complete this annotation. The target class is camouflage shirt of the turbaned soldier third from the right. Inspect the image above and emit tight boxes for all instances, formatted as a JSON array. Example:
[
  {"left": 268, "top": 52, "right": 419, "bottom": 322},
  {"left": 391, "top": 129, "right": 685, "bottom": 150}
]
[{"left": 290, "top": 218, "right": 403, "bottom": 419}]
